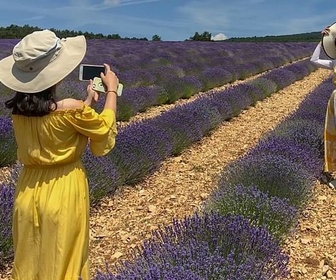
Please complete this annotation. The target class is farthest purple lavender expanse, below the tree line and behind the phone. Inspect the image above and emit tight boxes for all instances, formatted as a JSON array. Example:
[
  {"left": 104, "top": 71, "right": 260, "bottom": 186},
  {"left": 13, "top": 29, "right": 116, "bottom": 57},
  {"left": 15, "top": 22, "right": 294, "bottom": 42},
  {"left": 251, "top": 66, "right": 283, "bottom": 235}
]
[{"left": 0, "top": 39, "right": 314, "bottom": 121}]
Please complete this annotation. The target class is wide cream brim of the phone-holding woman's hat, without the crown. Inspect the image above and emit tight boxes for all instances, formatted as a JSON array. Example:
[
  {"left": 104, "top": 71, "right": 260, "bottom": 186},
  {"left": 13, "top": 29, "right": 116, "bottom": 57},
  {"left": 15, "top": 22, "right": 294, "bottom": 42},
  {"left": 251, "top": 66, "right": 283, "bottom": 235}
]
[{"left": 0, "top": 35, "right": 86, "bottom": 93}]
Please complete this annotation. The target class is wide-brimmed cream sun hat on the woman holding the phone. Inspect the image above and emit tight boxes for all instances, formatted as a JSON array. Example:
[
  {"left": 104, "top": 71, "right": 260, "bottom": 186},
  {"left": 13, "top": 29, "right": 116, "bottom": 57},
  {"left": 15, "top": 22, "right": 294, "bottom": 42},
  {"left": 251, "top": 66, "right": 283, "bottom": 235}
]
[{"left": 0, "top": 30, "right": 86, "bottom": 93}]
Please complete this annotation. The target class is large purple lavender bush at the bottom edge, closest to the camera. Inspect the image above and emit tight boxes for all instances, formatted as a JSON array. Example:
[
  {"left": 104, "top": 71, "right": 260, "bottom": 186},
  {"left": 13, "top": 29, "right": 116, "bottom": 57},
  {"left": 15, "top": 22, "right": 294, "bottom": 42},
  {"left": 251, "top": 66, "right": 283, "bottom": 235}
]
[{"left": 95, "top": 212, "right": 288, "bottom": 280}]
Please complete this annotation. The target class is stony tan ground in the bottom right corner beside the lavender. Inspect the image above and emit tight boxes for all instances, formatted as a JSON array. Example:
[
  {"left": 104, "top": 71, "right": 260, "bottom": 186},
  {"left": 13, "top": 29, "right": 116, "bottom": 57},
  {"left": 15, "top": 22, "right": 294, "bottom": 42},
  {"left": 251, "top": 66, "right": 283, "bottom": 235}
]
[{"left": 285, "top": 182, "right": 336, "bottom": 280}]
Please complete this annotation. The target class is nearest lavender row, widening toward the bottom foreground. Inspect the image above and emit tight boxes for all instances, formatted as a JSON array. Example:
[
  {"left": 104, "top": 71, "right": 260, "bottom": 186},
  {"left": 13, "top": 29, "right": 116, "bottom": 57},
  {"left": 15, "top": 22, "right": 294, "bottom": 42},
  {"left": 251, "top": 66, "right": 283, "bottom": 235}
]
[{"left": 95, "top": 69, "right": 333, "bottom": 280}]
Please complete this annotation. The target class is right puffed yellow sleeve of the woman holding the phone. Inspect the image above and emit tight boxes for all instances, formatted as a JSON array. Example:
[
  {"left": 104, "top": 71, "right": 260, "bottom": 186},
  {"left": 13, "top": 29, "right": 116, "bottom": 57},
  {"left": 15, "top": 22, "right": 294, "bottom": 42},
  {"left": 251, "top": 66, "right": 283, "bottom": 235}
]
[{"left": 68, "top": 104, "right": 117, "bottom": 156}]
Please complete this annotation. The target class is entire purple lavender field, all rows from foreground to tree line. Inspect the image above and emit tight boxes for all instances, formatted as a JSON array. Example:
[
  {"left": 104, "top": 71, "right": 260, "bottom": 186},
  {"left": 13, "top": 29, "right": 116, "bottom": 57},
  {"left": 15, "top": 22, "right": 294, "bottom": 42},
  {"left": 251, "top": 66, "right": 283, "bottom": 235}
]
[{"left": 0, "top": 40, "right": 331, "bottom": 279}]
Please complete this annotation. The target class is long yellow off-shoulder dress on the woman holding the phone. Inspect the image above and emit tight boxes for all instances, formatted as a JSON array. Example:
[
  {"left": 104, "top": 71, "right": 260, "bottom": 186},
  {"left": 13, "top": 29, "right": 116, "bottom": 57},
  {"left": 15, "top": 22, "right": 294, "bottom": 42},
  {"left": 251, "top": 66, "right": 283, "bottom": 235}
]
[{"left": 12, "top": 103, "right": 117, "bottom": 280}]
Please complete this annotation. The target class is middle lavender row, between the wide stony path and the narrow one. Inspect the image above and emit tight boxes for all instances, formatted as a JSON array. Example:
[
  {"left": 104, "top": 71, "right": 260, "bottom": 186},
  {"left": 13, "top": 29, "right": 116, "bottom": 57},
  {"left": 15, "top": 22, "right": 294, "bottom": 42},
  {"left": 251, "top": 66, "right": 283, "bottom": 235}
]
[{"left": 0, "top": 55, "right": 316, "bottom": 268}]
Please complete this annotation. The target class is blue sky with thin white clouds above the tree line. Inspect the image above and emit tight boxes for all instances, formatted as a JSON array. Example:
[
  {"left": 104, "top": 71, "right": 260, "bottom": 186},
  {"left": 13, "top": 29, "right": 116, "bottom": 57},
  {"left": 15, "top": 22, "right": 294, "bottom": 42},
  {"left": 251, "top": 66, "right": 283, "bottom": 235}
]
[{"left": 0, "top": 0, "right": 336, "bottom": 41}]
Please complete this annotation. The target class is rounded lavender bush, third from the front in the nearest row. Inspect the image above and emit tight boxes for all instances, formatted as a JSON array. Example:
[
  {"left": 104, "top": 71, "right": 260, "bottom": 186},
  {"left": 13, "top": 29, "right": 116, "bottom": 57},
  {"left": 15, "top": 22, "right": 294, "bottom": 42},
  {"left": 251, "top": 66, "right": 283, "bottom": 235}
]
[{"left": 219, "top": 154, "right": 314, "bottom": 207}]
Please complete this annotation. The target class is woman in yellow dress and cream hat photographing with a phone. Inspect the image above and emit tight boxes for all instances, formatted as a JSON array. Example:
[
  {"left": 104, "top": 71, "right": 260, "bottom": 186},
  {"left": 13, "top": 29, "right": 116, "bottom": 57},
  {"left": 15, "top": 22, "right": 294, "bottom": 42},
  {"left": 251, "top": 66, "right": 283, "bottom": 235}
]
[{"left": 0, "top": 30, "right": 119, "bottom": 280}]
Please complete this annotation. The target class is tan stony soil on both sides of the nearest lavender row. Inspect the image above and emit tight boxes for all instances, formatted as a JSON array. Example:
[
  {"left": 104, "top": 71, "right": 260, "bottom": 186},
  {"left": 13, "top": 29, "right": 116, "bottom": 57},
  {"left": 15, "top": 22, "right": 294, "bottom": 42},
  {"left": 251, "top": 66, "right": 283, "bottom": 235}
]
[{"left": 0, "top": 69, "right": 336, "bottom": 280}]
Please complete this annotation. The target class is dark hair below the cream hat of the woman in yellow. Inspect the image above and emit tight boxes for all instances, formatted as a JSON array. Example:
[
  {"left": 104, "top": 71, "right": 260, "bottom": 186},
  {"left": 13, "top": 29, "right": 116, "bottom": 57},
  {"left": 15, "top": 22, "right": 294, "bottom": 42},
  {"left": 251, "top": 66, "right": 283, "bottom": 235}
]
[{"left": 5, "top": 86, "right": 57, "bottom": 117}]
